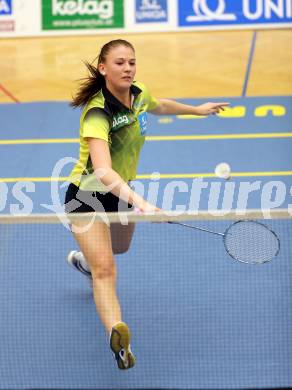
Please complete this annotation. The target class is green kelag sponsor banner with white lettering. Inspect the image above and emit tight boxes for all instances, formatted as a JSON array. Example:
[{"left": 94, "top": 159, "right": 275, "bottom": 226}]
[{"left": 41, "top": 0, "right": 124, "bottom": 30}]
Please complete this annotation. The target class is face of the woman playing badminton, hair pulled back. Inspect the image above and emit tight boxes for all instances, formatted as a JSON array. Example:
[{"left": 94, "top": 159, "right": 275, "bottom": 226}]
[{"left": 100, "top": 46, "right": 136, "bottom": 89}]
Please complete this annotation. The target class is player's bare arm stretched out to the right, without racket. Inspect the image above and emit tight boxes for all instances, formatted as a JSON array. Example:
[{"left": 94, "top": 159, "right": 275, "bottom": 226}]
[{"left": 149, "top": 99, "right": 229, "bottom": 115}]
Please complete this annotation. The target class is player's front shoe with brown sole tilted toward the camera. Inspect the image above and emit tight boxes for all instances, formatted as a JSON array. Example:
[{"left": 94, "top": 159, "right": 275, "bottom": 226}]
[{"left": 110, "top": 322, "right": 136, "bottom": 370}]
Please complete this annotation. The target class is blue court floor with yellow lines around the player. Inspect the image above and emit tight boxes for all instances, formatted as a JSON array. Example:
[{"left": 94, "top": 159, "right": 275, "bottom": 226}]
[{"left": 0, "top": 96, "right": 292, "bottom": 390}]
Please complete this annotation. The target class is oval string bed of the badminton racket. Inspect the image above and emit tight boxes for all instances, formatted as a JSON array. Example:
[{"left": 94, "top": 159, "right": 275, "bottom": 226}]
[{"left": 224, "top": 221, "right": 280, "bottom": 264}]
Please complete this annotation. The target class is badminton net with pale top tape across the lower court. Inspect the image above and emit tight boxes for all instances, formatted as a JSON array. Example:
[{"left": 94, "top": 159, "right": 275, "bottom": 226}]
[{"left": 0, "top": 210, "right": 292, "bottom": 390}]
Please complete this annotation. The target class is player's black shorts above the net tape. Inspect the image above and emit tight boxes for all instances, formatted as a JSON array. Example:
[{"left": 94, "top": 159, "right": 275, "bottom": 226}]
[{"left": 65, "top": 183, "right": 133, "bottom": 213}]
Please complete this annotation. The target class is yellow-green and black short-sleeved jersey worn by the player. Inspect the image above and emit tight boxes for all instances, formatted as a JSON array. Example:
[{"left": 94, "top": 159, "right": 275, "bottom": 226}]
[{"left": 69, "top": 82, "right": 158, "bottom": 191}]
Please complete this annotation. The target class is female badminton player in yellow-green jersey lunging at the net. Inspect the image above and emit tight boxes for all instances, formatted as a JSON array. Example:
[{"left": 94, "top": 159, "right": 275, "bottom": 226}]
[{"left": 65, "top": 39, "right": 228, "bottom": 369}]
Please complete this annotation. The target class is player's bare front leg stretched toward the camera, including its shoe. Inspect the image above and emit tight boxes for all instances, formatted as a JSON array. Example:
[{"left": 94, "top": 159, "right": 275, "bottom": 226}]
[{"left": 72, "top": 221, "right": 135, "bottom": 369}]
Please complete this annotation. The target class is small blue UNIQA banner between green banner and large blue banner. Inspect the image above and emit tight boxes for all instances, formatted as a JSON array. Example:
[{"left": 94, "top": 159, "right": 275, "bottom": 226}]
[{"left": 135, "top": 0, "right": 168, "bottom": 23}]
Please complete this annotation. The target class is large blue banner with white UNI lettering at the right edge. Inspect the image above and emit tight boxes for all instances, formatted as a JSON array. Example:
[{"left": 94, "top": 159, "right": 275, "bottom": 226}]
[{"left": 178, "top": 0, "right": 292, "bottom": 27}]
